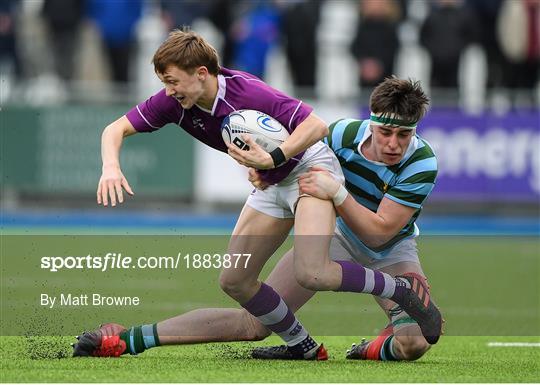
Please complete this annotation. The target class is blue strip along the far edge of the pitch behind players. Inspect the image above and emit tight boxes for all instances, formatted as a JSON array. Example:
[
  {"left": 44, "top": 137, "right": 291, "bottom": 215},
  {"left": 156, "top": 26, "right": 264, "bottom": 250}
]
[{"left": 0, "top": 211, "right": 540, "bottom": 236}]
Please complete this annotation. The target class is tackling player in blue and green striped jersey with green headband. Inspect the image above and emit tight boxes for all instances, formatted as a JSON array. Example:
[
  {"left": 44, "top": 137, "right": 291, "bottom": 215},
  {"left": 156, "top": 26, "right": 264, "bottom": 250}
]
[{"left": 299, "top": 78, "right": 437, "bottom": 360}]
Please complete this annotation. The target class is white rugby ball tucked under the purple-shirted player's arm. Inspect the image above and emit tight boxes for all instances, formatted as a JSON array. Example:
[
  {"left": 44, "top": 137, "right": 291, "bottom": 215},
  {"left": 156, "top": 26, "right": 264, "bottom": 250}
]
[{"left": 221, "top": 110, "right": 289, "bottom": 152}]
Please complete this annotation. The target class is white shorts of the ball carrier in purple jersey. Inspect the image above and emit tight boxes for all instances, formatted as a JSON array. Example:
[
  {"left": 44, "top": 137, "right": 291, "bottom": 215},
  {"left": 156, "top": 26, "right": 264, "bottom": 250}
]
[{"left": 246, "top": 142, "right": 345, "bottom": 219}]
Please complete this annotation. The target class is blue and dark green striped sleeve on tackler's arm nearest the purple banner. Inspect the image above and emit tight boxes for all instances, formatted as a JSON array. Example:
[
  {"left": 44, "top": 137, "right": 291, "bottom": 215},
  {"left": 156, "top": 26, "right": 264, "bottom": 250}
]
[{"left": 384, "top": 146, "right": 437, "bottom": 209}]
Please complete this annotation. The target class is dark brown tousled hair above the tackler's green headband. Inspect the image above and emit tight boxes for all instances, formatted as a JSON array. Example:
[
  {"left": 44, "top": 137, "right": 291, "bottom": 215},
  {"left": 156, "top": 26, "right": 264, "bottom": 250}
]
[{"left": 369, "top": 76, "right": 429, "bottom": 123}]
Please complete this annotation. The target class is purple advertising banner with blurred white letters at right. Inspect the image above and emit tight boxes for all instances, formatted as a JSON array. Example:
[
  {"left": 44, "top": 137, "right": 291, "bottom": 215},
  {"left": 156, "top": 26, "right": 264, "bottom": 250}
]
[{"left": 418, "top": 109, "right": 540, "bottom": 202}]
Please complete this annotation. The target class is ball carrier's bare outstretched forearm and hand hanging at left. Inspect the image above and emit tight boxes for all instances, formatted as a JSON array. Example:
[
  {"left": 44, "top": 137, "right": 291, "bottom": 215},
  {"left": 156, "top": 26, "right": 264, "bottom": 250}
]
[{"left": 97, "top": 115, "right": 137, "bottom": 207}]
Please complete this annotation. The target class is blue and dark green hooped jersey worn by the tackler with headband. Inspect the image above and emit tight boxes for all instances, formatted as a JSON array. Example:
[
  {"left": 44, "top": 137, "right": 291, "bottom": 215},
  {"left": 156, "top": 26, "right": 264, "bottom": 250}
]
[{"left": 324, "top": 119, "right": 437, "bottom": 259}]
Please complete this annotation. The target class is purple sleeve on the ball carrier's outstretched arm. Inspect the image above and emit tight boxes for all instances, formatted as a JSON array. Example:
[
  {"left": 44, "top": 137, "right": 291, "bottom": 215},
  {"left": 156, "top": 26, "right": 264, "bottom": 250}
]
[{"left": 126, "top": 89, "right": 181, "bottom": 132}]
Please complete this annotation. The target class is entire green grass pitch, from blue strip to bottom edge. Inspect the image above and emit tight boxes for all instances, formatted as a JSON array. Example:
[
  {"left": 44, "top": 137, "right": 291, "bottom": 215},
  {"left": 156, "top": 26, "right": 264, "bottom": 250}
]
[{"left": 0, "top": 235, "right": 540, "bottom": 382}]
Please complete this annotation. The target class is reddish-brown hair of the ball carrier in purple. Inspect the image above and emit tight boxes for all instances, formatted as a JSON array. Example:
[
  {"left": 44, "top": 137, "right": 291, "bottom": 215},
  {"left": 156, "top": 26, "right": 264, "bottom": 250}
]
[{"left": 152, "top": 29, "right": 219, "bottom": 76}]
